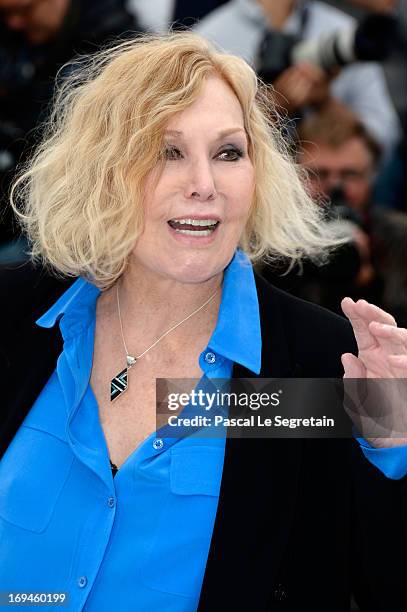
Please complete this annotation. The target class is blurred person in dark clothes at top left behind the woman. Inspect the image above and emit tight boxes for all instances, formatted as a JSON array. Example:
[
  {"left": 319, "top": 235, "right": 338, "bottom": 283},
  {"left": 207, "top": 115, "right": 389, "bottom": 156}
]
[{"left": 0, "top": 0, "right": 138, "bottom": 249}]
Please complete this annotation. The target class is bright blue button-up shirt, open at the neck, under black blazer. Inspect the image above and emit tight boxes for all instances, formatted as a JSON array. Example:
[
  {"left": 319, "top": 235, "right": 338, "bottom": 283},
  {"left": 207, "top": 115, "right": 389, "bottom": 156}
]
[{"left": 0, "top": 251, "right": 407, "bottom": 612}]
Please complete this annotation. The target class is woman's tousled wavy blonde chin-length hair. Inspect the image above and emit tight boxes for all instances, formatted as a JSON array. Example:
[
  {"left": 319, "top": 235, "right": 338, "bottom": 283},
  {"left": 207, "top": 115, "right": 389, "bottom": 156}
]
[{"left": 11, "top": 32, "right": 345, "bottom": 290}]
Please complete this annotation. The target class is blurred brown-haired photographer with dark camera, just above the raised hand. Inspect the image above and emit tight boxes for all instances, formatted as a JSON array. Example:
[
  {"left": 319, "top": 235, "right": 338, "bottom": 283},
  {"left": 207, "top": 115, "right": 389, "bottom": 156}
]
[{"left": 264, "top": 101, "right": 383, "bottom": 314}]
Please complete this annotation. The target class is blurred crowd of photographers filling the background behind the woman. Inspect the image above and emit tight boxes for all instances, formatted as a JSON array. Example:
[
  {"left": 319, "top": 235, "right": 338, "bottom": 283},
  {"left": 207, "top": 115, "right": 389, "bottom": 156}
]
[{"left": 0, "top": 0, "right": 407, "bottom": 326}]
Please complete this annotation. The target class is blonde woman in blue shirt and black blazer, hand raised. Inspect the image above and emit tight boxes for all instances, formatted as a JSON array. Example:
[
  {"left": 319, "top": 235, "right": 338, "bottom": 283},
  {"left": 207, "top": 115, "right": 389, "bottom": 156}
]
[{"left": 0, "top": 33, "right": 407, "bottom": 611}]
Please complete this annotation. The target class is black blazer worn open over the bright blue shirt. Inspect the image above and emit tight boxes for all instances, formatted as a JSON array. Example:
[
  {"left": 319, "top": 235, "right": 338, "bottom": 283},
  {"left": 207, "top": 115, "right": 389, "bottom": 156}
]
[{"left": 0, "top": 268, "right": 407, "bottom": 612}]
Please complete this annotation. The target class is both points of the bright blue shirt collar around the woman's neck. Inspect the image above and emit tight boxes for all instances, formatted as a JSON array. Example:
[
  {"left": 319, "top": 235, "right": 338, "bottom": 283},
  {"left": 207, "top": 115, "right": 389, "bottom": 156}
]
[{"left": 36, "top": 250, "right": 261, "bottom": 374}]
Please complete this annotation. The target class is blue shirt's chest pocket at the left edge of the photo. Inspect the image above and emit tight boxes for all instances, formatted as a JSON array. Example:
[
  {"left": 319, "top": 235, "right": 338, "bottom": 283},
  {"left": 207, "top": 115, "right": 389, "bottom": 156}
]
[{"left": 0, "top": 425, "right": 74, "bottom": 533}]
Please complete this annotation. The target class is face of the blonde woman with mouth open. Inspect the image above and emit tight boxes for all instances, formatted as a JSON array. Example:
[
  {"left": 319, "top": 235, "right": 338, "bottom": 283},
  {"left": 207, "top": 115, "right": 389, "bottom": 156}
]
[{"left": 133, "top": 77, "right": 254, "bottom": 283}]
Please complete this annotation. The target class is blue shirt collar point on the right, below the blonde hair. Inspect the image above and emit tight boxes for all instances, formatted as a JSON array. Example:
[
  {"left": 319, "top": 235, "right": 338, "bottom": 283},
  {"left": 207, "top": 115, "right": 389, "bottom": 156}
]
[{"left": 209, "top": 250, "right": 261, "bottom": 374}]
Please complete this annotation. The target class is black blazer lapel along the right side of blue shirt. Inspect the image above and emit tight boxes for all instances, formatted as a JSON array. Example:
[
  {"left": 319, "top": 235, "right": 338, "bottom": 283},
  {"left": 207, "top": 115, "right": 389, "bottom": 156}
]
[{"left": 198, "top": 276, "right": 303, "bottom": 611}]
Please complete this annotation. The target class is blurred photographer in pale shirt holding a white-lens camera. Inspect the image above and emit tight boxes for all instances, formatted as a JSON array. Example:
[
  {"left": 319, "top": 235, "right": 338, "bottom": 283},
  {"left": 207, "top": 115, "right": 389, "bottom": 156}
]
[{"left": 196, "top": 0, "right": 400, "bottom": 152}]
